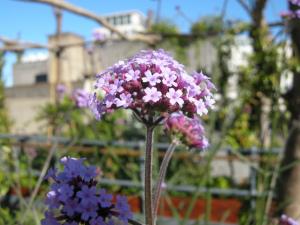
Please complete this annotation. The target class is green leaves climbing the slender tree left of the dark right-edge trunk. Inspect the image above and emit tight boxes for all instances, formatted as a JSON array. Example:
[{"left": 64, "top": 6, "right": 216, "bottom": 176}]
[{"left": 239, "top": 34, "right": 284, "bottom": 135}]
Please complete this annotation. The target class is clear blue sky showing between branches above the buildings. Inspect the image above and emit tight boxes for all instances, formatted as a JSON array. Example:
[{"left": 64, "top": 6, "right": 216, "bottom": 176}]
[{"left": 0, "top": 0, "right": 287, "bottom": 86}]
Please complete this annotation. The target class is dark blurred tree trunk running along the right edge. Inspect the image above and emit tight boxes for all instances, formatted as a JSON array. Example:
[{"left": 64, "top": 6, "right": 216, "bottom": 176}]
[{"left": 278, "top": 1, "right": 300, "bottom": 222}]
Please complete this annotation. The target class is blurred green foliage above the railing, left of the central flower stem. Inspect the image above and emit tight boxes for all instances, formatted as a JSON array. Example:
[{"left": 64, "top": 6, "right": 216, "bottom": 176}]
[{"left": 37, "top": 96, "right": 139, "bottom": 141}]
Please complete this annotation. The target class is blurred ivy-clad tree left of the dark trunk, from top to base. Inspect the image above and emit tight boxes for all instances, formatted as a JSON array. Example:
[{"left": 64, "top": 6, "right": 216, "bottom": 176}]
[{"left": 239, "top": 0, "right": 281, "bottom": 148}]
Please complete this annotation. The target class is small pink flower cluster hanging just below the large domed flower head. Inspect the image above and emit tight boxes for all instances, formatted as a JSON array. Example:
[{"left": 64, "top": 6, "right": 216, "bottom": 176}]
[{"left": 165, "top": 113, "right": 208, "bottom": 149}]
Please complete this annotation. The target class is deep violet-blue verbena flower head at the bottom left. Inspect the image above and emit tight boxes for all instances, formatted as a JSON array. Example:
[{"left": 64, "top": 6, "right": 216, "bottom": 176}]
[{"left": 41, "top": 157, "right": 132, "bottom": 225}]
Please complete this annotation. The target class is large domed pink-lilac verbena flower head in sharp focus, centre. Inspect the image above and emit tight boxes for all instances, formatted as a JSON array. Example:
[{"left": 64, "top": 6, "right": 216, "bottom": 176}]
[{"left": 90, "top": 50, "right": 214, "bottom": 123}]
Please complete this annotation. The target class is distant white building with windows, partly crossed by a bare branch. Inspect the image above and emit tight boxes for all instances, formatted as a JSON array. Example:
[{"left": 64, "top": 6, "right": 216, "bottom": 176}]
[{"left": 93, "top": 11, "right": 146, "bottom": 39}]
